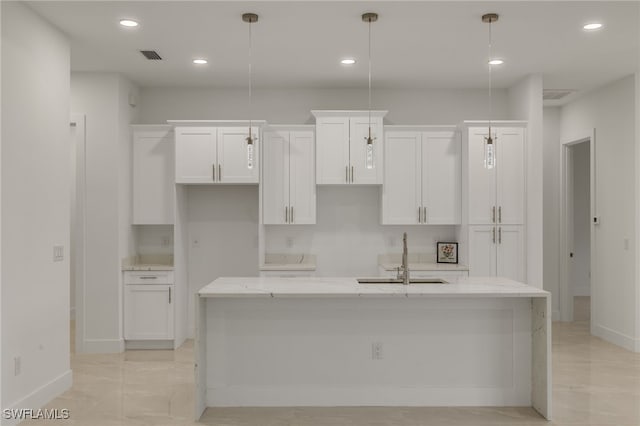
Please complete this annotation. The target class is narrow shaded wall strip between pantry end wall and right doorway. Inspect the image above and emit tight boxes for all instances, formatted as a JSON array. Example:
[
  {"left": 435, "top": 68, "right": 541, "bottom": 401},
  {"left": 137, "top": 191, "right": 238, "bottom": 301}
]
[{"left": 542, "top": 107, "right": 560, "bottom": 320}]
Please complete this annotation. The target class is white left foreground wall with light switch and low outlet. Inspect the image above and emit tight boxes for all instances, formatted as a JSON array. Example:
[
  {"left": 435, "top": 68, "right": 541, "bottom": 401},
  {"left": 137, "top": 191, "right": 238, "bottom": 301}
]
[{"left": 0, "top": 2, "right": 71, "bottom": 424}]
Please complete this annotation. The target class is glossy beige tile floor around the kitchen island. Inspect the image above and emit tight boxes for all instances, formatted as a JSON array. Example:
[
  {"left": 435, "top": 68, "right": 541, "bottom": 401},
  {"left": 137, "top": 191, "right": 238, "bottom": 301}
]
[{"left": 22, "top": 321, "right": 640, "bottom": 426}]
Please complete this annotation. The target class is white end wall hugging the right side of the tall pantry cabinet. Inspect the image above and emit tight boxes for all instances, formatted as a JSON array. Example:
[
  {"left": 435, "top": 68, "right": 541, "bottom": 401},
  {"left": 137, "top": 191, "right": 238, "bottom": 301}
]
[{"left": 509, "top": 75, "right": 544, "bottom": 288}]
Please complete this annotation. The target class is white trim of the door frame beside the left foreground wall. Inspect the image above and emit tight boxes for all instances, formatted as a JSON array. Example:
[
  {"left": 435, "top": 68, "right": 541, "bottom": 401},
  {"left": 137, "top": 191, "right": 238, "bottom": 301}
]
[{"left": 69, "top": 114, "right": 87, "bottom": 353}]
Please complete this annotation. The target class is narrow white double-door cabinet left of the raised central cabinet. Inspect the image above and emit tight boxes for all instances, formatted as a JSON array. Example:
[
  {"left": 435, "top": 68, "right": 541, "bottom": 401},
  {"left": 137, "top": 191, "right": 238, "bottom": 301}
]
[{"left": 262, "top": 126, "right": 316, "bottom": 225}]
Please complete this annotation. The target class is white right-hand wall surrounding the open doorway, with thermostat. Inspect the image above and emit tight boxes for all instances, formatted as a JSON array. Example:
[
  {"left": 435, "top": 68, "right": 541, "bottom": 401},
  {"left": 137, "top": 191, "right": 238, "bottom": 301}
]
[{"left": 561, "top": 76, "right": 640, "bottom": 350}]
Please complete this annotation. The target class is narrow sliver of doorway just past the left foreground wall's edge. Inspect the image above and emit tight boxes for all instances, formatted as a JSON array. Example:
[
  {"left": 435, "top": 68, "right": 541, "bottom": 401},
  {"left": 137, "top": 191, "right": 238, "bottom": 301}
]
[{"left": 69, "top": 114, "right": 86, "bottom": 353}]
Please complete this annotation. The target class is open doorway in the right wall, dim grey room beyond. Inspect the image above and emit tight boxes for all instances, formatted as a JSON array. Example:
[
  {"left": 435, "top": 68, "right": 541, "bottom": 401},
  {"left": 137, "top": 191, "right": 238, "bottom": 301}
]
[{"left": 560, "top": 137, "right": 595, "bottom": 322}]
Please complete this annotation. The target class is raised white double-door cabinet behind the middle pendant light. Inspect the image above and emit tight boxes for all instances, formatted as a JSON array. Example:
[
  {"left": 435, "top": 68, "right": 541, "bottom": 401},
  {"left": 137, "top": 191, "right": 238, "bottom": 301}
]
[{"left": 311, "top": 111, "right": 386, "bottom": 185}]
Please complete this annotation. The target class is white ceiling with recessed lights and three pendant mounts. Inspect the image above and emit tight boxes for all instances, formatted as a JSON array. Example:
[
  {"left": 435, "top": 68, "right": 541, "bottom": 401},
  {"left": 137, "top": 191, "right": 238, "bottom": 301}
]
[{"left": 28, "top": 1, "right": 640, "bottom": 97}]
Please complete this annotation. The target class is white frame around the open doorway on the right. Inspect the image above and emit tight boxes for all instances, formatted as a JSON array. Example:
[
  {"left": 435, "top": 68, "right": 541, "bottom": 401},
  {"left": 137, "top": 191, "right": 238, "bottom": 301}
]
[{"left": 558, "top": 129, "right": 597, "bottom": 324}]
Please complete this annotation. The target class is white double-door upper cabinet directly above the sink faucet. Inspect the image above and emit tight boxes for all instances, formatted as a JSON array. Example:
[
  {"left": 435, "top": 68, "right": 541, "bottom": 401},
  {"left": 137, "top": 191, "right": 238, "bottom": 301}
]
[{"left": 382, "top": 126, "right": 462, "bottom": 225}]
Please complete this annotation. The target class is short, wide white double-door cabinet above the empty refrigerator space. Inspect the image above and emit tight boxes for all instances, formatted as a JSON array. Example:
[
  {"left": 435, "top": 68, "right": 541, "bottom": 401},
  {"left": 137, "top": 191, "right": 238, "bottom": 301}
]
[{"left": 175, "top": 125, "right": 261, "bottom": 184}]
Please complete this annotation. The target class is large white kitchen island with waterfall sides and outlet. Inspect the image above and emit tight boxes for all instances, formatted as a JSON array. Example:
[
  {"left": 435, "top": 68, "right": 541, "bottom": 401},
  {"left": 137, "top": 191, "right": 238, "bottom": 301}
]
[{"left": 195, "top": 277, "right": 551, "bottom": 419}]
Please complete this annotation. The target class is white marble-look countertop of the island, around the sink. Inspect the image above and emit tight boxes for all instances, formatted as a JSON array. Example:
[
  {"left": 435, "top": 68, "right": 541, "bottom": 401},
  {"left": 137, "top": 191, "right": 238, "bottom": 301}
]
[{"left": 198, "top": 277, "right": 549, "bottom": 298}]
